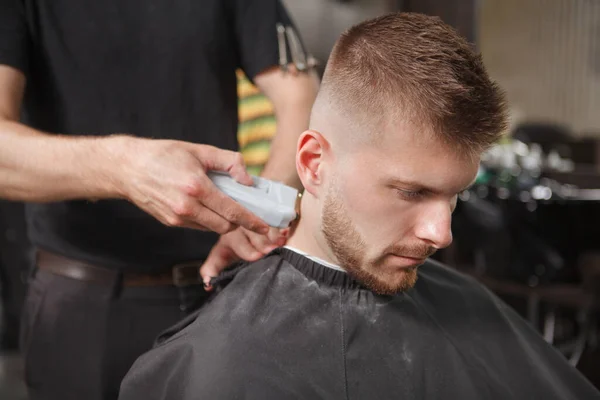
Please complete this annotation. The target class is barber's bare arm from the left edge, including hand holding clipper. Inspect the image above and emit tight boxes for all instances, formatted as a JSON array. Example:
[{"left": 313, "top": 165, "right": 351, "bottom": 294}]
[{"left": 0, "top": 65, "right": 267, "bottom": 233}]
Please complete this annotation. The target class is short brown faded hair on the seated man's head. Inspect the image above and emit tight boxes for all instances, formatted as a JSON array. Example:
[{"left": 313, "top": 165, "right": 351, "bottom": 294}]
[{"left": 315, "top": 13, "right": 507, "bottom": 154}]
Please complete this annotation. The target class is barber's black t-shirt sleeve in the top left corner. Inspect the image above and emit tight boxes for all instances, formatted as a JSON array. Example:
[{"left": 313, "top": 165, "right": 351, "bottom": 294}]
[{"left": 0, "top": 0, "right": 29, "bottom": 73}]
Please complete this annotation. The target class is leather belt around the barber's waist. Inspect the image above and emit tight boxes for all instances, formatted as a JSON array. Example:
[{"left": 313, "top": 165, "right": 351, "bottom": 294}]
[{"left": 37, "top": 249, "right": 202, "bottom": 287}]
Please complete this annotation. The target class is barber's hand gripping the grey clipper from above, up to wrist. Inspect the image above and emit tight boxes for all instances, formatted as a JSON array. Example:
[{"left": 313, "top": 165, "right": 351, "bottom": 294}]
[{"left": 116, "top": 138, "right": 269, "bottom": 234}]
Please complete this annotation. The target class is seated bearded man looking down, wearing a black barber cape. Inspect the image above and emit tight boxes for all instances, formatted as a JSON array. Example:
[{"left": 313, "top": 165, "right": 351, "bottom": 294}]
[{"left": 120, "top": 13, "right": 600, "bottom": 400}]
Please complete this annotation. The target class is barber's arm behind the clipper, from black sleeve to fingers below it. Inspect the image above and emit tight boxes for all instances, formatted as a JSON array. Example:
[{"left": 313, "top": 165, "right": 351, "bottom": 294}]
[{"left": 200, "top": 0, "right": 318, "bottom": 283}]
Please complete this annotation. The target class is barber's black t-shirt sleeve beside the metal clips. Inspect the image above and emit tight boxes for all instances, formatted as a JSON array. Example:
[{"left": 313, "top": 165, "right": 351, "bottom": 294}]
[{"left": 233, "top": 0, "right": 298, "bottom": 79}]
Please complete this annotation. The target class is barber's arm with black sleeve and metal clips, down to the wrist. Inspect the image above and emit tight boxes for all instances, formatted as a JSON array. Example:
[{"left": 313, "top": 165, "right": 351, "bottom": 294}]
[{"left": 224, "top": 0, "right": 319, "bottom": 189}]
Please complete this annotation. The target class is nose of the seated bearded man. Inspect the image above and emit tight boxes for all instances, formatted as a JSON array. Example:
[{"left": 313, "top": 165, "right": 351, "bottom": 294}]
[{"left": 415, "top": 203, "right": 452, "bottom": 249}]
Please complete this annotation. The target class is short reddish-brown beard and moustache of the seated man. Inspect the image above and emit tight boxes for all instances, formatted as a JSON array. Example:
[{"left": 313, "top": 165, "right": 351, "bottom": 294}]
[{"left": 321, "top": 184, "right": 435, "bottom": 295}]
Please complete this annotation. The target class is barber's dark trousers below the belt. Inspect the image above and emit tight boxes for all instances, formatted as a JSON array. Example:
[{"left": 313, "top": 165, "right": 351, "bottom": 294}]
[{"left": 21, "top": 262, "right": 206, "bottom": 400}]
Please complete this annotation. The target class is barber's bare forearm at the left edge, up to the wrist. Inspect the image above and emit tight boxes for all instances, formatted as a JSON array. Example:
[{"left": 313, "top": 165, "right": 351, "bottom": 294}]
[{"left": 0, "top": 120, "right": 120, "bottom": 202}]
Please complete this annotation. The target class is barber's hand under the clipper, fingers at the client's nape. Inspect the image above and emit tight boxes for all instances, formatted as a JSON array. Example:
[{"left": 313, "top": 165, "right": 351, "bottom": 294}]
[{"left": 200, "top": 228, "right": 289, "bottom": 290}]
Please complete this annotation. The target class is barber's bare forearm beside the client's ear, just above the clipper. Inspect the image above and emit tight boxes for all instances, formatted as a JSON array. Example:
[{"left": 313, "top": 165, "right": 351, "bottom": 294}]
[{"left": 261, "top": 104, "right": 312, "bottom": 189}]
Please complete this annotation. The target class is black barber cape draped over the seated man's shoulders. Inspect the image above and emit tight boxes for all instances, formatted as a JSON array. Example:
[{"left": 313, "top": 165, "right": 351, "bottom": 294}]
[{"left": 120, "top": 249, "right": 600, "bottom": 400}]
